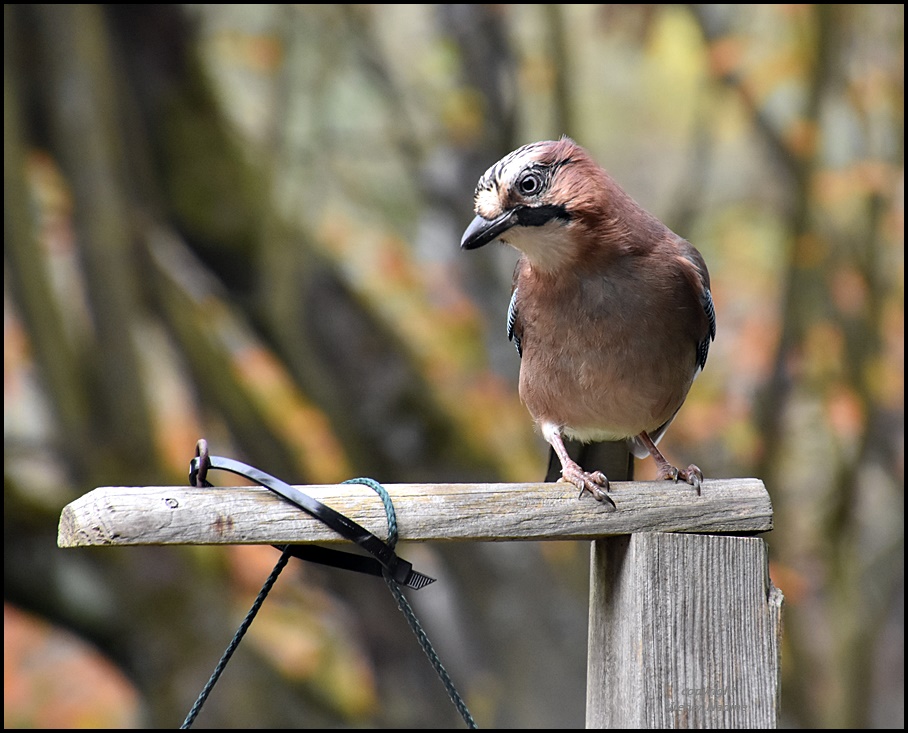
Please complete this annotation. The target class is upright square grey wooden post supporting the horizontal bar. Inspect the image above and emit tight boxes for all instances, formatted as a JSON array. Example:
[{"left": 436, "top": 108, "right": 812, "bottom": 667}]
[{"left": 586, "top": 533, "right": 782, "bottom": 728}]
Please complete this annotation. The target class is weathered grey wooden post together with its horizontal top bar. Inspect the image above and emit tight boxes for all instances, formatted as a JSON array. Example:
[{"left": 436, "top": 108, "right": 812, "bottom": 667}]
[{"left": 57, "top": 479, "right": 781, "bottom": 728}]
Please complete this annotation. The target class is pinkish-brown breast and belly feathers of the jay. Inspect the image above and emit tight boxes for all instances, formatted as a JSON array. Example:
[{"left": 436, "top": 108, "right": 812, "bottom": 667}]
[{"left": 515, "top": 271, "right": 696, "bottom": 440}]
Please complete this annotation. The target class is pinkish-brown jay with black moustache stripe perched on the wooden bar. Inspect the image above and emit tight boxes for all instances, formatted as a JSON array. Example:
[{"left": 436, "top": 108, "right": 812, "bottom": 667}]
[{"left": 460, "top": 136, "right": 716, "bottom": 510}]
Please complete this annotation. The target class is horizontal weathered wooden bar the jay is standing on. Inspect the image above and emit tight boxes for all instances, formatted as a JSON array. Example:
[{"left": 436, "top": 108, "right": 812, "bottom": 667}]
[{"left": 57, "top": 479, "right": 772, "bottom": 547}]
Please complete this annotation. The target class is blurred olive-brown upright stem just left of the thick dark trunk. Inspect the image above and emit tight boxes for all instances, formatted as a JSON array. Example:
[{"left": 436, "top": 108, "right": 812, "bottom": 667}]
[{"left": 36, "top": 5, "right": 154, "bottom": 479}]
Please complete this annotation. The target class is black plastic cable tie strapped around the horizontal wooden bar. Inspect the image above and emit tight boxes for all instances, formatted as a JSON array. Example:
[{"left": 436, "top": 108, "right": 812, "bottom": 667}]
[{"left": 189, "top": 455, "right": 435, "bottom": 590}]
